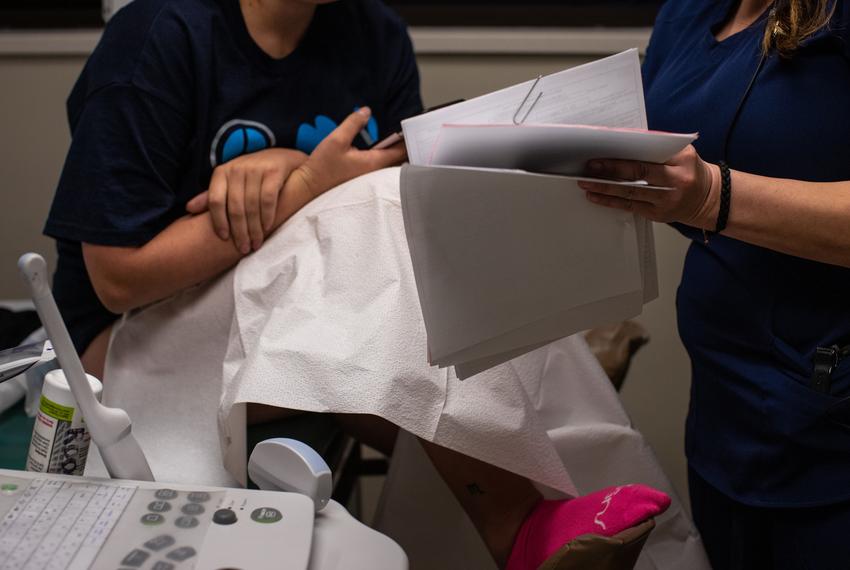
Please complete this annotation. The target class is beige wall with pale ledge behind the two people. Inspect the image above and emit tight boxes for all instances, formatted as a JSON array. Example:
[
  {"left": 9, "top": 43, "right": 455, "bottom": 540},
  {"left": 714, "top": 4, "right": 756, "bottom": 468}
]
[{"left": 0, "top": 31, "right": 689, "bottom": 506}]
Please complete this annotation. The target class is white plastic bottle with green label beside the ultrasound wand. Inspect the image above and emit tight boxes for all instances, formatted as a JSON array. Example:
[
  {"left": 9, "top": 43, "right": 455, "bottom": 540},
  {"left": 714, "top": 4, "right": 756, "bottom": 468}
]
[{"left": 27, "top": 370, "right": 103, "bottom": 475}]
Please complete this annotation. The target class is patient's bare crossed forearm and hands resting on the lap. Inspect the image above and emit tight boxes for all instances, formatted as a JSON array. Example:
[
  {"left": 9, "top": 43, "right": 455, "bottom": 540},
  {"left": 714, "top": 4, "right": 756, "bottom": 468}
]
[{"left": 83, "top": 108, "right": 405, "bottom": 313}]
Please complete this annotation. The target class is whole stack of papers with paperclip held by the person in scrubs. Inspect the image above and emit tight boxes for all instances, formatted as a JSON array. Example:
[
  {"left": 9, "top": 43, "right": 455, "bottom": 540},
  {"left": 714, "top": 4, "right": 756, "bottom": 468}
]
[{"left": 401, "top": 50, "right": 695, "bottom": 378}]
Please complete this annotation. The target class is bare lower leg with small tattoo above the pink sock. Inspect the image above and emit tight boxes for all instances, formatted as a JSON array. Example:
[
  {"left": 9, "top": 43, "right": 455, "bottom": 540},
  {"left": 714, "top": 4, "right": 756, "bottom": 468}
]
[{"left": 419, "top": 439, "right": 542, "bottom": 568}]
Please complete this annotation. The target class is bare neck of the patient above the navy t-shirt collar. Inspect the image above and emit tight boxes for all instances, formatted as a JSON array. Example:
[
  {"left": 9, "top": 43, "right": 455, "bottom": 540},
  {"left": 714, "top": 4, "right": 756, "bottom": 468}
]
[{"left": 239, "top": 0, "right": 316, "bottom": 59}]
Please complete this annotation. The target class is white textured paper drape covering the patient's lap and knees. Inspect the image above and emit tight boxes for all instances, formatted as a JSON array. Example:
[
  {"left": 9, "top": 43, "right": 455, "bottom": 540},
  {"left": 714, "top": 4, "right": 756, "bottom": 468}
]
[{"left": 221, "top": 169, "right": 574, "bottom": 493}]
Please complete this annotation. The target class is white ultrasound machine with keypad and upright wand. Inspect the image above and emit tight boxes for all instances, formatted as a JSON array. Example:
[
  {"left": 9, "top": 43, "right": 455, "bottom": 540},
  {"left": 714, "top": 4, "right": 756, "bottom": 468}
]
[{"left": 0, "top": 254, "right": 408, "bottom": 570}]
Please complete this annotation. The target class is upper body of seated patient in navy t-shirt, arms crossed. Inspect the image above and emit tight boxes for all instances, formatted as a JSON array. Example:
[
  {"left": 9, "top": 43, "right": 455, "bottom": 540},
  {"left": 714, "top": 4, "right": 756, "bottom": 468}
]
[{"left": 45, "top": 0, "right": 422, "bottom": 376}]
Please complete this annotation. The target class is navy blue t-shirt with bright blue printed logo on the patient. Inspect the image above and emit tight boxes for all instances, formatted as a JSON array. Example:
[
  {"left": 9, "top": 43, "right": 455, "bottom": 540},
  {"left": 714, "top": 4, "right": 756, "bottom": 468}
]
[{"left": 45, "top": 0, "right": 422, "bottom": 352}]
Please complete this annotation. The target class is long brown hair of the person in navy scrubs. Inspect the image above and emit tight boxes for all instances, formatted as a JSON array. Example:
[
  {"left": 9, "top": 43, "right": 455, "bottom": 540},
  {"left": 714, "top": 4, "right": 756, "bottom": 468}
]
[{"left": 762, "top": 0, "right": 839, "bottom": 57}]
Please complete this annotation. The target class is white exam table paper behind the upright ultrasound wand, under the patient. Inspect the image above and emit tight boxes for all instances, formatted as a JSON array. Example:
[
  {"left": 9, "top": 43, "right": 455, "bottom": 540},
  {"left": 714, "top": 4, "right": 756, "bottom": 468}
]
[{"left": 97, "top": 272, "right": 246, "bottom": 486}]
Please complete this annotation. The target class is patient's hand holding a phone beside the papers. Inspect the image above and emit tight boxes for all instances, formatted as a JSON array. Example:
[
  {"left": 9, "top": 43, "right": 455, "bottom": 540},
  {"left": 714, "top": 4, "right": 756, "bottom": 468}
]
[{"left": 287, "top": 107, "right": 407, "bottom": 203}]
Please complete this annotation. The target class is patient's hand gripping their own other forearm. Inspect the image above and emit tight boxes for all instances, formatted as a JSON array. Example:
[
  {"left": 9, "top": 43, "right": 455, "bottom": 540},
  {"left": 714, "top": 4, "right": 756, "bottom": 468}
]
[{"left": 186, "top": 148, "right": 307, "bottom": 254}]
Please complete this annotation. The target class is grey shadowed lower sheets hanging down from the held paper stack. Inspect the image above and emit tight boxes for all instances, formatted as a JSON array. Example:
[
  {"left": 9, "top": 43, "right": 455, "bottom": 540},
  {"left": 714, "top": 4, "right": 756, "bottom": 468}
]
[{"left": 401, "top": 166, "right": 643, "bottom": 378}]
